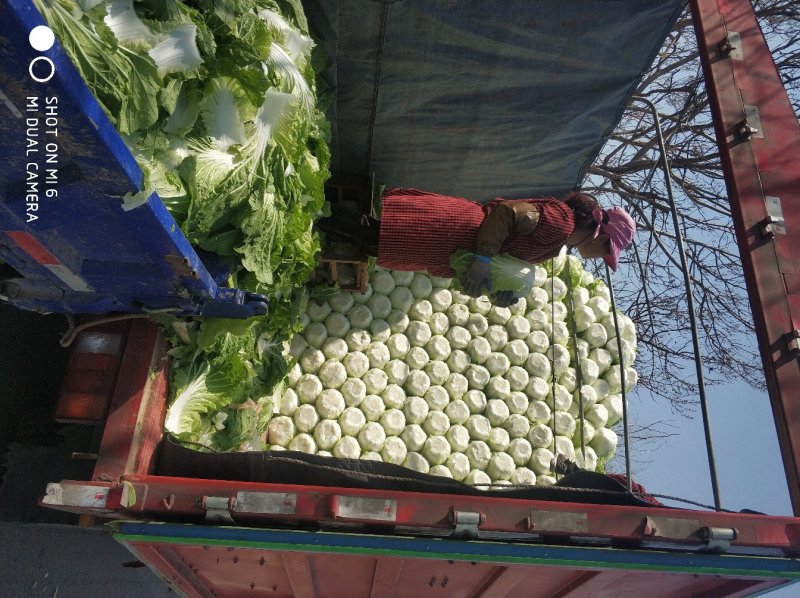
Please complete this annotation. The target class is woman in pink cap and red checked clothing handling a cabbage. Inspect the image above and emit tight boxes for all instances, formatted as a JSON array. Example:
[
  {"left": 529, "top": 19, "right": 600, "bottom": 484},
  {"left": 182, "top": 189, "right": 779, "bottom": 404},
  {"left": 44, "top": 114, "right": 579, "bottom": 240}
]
[{"left": 319, "top": 188, "right": 636, "bottom": 305}]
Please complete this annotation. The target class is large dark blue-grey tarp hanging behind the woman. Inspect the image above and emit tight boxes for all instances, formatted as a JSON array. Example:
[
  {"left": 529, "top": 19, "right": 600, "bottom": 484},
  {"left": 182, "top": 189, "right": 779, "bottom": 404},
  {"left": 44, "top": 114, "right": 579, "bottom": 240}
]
[{"left": 303, "top": 0, "right": 683, "bottom": 201}]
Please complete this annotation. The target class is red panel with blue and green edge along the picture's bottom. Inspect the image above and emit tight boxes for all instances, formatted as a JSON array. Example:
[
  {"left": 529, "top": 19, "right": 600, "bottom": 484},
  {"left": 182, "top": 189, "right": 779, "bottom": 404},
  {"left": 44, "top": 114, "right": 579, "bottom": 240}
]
[{"left": 116, "top": 523, "right": 800, "bottom": 598}]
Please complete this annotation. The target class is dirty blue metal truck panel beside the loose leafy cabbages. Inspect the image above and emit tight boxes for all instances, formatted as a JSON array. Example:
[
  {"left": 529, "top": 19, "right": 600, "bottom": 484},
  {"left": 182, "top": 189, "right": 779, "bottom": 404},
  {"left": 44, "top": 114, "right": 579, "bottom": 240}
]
[{"left": 0, "top": 0, "right": 266, "bottom": 317}]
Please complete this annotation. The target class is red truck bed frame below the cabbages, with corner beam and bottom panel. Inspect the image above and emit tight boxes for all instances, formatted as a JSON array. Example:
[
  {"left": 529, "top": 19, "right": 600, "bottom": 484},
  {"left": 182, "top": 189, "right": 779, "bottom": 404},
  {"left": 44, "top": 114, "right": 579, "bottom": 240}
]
[{"left": 42, "top": 321, "right": 800, "bottom": 597}]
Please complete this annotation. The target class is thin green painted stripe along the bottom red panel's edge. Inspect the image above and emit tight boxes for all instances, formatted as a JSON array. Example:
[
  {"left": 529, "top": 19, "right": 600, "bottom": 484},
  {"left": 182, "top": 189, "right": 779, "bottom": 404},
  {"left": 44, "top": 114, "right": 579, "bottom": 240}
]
[{"left": 114, "top": 533, "right": 800, "bottom": 579}]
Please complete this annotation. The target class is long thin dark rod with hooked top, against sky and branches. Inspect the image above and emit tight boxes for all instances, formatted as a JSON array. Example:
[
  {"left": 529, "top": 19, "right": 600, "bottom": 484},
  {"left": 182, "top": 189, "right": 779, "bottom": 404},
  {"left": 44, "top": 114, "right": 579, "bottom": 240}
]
[{"left": 633, "top": 96, "right": 722, "bottom": 511}]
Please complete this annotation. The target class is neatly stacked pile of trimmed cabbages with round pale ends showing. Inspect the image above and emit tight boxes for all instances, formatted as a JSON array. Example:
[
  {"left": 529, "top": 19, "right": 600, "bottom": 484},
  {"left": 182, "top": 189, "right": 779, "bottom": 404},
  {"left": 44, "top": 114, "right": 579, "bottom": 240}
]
[{"left": 266, "top": 255, "right": 637, "bottom": 487}]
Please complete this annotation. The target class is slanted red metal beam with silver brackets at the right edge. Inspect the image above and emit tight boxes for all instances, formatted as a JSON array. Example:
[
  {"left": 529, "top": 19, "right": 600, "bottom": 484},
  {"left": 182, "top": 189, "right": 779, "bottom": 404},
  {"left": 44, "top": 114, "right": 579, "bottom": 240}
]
[{"left": 690, "top": 0, "right": 800, "bottom": 515}]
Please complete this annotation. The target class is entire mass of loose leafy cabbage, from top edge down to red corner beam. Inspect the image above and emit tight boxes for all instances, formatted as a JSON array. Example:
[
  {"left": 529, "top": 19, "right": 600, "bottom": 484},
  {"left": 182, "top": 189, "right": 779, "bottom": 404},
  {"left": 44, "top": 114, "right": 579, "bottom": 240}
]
[{"left": 35, "top": 0, "right": 330, "bottom": 450}]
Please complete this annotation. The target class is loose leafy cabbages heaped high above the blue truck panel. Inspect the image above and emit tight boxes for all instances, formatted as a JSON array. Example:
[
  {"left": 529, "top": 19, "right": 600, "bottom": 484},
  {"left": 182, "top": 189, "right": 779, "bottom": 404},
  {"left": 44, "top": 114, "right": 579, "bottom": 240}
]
[{"left": 37, "top": 0, "right": 330, "bottom": 298}]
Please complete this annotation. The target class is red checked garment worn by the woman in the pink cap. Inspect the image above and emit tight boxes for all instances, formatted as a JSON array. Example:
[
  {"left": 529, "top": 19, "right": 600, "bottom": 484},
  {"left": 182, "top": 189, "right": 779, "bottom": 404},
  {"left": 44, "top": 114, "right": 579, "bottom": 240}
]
[{"left": 377, "top": 189, "right": 575, "bottom": 278}]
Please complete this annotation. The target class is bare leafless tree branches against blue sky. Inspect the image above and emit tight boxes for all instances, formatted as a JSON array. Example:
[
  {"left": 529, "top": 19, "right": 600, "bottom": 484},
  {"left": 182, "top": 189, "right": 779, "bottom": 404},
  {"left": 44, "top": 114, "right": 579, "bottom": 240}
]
[{"left": 584, "top": 0, "right": 800, "bottom": 415}]
